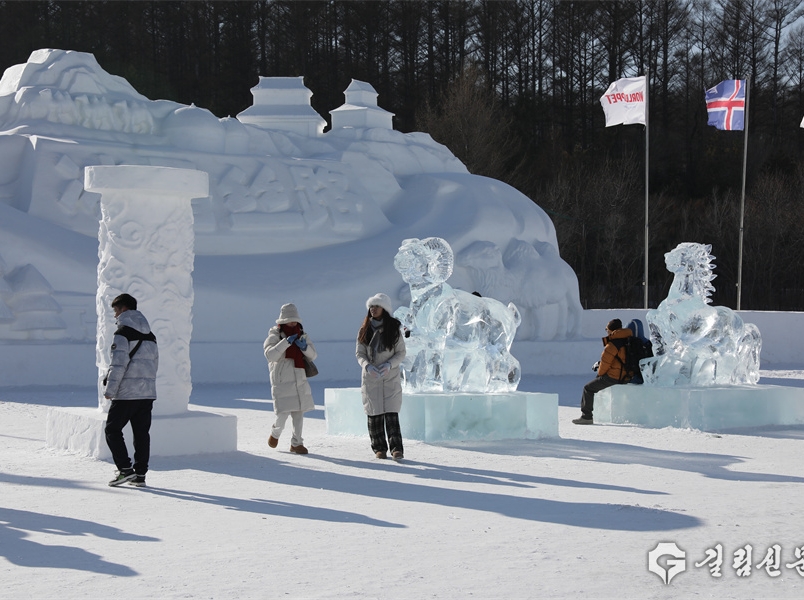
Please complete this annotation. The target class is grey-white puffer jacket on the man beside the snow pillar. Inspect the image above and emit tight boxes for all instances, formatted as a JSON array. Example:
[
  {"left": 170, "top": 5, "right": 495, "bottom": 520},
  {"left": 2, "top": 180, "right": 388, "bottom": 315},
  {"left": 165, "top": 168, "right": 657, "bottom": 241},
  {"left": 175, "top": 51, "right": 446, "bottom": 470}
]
[{"left": 104, "top": 310, "right": 159, "bottom": 400}]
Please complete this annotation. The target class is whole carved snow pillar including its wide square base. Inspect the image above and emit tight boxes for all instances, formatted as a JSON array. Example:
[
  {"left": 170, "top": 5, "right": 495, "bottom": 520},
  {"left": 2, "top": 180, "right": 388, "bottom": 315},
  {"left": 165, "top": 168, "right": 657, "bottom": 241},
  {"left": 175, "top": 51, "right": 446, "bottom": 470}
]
[{"left": 45, "top": 165, "right": 237, "bottom": 459}]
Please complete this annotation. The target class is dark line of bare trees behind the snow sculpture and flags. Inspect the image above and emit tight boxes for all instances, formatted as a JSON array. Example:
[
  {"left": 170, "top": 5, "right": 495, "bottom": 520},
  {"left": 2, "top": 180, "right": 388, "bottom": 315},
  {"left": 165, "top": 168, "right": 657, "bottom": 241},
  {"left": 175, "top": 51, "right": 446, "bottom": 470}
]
[{"left": 0, "top": 0, "right": 804, "bottom": 310}]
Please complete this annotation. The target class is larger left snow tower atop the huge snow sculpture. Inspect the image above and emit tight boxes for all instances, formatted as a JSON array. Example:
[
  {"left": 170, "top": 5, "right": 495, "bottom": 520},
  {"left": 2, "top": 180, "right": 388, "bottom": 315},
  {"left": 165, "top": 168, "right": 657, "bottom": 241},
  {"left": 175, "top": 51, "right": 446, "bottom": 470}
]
[{"left": 237, "top": 77, "right": 327, "bottom": 137}]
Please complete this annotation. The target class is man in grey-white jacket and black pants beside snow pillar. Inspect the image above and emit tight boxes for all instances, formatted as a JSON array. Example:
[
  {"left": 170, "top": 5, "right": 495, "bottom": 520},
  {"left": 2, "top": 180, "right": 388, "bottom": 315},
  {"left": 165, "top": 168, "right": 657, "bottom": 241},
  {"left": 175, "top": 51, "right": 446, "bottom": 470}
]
[{"left": 103, "top": 294, "right": 159, "bottom": 487}]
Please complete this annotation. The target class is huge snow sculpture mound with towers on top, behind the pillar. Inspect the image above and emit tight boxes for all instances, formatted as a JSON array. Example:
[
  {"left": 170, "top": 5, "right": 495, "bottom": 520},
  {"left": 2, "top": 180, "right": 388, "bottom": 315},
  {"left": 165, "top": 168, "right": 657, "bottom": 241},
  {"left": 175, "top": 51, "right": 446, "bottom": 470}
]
[{"left": 0, "top": 49, "right": 582, "bottom": 352}]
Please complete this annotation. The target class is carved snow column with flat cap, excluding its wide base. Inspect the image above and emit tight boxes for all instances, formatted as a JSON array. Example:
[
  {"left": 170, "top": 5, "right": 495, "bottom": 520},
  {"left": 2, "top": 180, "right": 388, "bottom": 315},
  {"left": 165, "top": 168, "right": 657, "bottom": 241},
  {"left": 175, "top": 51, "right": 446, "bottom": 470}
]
[{"left": 84, "top": 165, "right": 209, "bottom": 415}]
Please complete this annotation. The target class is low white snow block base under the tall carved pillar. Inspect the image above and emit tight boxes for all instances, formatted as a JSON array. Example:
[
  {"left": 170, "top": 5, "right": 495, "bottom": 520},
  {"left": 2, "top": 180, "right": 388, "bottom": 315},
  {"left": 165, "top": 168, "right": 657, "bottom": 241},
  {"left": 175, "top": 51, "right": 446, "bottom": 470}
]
[{"left": 45, "top": 408, "right": 237, "bottom": 460}]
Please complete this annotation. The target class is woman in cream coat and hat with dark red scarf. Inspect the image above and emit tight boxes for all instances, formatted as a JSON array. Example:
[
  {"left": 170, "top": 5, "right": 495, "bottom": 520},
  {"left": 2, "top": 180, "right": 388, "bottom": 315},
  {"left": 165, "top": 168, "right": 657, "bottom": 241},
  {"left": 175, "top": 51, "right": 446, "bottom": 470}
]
[{"left": 262, "top": 304, "right": 317, "bottom": 454}]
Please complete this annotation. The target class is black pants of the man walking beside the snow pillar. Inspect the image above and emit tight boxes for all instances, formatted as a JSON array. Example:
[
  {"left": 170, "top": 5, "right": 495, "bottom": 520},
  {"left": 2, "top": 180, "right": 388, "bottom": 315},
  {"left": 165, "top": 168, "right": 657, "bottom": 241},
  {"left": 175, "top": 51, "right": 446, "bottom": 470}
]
[{"left": 105, "top": 400, "right": 154, "bottom": 475}]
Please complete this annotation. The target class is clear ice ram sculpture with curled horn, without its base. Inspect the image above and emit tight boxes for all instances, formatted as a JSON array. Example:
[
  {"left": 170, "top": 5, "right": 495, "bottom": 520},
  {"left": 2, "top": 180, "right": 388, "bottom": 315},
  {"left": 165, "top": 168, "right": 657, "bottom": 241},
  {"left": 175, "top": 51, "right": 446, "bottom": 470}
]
[{"left": 394, "top": 237, "right": 522, "bottom": 393}]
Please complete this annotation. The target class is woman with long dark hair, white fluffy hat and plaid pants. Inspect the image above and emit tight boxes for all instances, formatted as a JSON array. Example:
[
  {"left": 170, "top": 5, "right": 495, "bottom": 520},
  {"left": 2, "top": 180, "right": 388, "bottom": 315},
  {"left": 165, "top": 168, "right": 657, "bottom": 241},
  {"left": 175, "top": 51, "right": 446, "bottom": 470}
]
[{"left": 355, "top": 294, "right": 405, "bottom": 460}]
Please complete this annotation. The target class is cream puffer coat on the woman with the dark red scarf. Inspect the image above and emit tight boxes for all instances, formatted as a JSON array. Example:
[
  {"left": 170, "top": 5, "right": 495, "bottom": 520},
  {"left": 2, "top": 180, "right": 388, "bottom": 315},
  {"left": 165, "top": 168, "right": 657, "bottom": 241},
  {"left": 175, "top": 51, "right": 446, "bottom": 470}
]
[{"left": 262, "top": 325, "right": 318, "bottom": 413}]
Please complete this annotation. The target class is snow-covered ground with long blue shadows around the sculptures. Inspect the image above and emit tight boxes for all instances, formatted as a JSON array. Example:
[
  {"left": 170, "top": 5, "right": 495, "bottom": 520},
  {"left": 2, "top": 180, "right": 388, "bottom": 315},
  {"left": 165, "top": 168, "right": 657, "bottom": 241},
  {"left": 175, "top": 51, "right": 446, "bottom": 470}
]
[{"left": 0, "top": 371, "right": 804, "bottom": 598}]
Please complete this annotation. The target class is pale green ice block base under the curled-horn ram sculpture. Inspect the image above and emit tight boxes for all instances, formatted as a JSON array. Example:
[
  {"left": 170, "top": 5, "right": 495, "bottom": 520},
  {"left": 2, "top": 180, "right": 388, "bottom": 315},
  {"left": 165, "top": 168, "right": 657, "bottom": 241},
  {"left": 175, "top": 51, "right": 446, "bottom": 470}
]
[{"left": 324, "top": 388, "right": 558, "bottom": 442}]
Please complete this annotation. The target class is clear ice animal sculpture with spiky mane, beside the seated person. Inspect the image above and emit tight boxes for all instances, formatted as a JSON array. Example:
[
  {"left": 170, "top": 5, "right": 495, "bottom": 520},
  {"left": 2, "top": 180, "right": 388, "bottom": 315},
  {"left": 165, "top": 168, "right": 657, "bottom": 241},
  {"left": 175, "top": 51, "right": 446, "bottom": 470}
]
[{"left": 641, "top": 242, "right": 762, "bottom": 387}]
